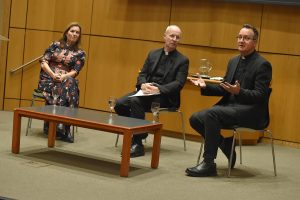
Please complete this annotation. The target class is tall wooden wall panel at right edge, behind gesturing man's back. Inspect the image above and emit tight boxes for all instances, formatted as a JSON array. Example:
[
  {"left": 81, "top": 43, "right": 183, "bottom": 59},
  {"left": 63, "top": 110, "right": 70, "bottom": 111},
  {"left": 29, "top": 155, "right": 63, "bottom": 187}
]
[{"left": 264, "top": 54, "right": 300, "bottom": 142}]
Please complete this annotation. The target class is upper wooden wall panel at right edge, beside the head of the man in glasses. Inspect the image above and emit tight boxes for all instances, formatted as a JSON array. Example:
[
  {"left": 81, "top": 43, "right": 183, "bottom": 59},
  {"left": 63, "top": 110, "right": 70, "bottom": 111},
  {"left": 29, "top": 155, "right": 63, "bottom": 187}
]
[{"left": 260, "top": 5, "right": 300, "bottom": 55}]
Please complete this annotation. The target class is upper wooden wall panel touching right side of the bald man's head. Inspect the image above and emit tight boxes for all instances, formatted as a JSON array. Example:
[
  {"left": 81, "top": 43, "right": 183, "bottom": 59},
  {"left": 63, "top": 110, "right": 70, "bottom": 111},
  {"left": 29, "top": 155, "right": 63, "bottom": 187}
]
[{"left": 171, "top": 0, "right": 213, "bottom": 46}]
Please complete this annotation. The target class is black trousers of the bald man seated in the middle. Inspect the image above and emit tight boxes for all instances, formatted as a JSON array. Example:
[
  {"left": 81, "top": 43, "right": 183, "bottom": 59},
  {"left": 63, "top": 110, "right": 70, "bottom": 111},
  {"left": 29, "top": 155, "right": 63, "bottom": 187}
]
[{"left": 115, "top": 92, "right": 171, "bottom": 145}]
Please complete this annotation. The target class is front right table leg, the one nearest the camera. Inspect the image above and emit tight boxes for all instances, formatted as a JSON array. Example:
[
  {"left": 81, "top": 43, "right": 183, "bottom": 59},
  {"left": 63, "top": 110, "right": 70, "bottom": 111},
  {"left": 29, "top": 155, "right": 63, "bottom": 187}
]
[{"left": 120, "top": 132, "right": 132, "bottom": 177}]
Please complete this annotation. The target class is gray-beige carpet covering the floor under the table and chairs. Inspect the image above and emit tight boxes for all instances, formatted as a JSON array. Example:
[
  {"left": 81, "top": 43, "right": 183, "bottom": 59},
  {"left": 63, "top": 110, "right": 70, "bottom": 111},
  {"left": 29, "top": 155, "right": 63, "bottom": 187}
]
[{"left": 0, "top": 111, "right": 300, "bottom": 200}]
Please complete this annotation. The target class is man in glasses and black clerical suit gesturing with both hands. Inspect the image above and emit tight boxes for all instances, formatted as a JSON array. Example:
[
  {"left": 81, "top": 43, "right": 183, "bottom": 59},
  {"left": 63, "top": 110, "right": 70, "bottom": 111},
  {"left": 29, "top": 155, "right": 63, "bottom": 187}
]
[{"left": 185, "top": 24, "right": 272, "bottom": 177}]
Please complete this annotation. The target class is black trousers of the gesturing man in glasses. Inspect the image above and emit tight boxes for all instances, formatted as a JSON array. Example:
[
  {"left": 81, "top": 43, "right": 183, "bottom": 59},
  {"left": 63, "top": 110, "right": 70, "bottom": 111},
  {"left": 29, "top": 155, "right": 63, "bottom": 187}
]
[{"left": 190, "top": 105, "right": 239, "bottom": 160}]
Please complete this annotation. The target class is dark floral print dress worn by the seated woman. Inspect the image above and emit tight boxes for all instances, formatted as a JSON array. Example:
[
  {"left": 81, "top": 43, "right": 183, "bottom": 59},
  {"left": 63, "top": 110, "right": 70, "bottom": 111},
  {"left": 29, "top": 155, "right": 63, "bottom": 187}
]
[{"left": 38, "top": 42, "right": 85, "bottom": 107}]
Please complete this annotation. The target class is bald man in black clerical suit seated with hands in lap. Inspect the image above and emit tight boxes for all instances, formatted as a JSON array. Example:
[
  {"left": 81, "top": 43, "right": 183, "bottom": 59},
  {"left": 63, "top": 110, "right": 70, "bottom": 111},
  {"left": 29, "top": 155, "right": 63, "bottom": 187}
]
[{"left": 115, "top": 25, "right": 189, "bottom": 157}]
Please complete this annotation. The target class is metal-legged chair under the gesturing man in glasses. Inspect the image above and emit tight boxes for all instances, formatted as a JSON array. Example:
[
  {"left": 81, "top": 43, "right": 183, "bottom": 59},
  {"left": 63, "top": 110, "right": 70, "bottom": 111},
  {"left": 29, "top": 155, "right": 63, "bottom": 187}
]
[{"left": 197, "top": 88, "right": 277, "bottom": 177}]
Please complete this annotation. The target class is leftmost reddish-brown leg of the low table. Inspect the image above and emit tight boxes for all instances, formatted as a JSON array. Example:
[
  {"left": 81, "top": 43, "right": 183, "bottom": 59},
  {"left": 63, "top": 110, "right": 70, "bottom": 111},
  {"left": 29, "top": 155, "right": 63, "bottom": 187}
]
[{"left": 11, "top": 111, "right": 21, "bottom": 153}]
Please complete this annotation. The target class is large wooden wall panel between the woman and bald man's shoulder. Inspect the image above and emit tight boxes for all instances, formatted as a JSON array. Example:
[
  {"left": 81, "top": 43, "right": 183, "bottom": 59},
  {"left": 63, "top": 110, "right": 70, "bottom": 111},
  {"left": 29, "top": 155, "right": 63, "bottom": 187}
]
[{"left": 84, "top": 37, "right": 163, "bottom": 110}]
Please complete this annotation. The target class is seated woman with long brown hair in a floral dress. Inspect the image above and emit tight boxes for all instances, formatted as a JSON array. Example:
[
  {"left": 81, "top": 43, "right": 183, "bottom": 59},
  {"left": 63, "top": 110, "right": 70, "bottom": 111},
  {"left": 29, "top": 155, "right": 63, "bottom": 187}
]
[{"left": 38, "top": 23, "right": 85, "bottom": 143}]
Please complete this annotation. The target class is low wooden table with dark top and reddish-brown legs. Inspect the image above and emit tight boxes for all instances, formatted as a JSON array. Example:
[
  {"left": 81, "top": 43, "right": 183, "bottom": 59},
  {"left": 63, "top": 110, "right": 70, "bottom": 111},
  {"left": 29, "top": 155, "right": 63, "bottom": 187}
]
[{"left": 11, "top": 105, "right": 162, "bottom": 177}]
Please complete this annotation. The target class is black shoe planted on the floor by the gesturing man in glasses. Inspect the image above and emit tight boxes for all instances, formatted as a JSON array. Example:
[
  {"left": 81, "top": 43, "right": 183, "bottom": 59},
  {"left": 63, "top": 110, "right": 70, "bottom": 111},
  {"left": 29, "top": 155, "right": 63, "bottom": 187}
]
[{"left": 185, "top": 161, "right": 217, "bottom": 177}]
